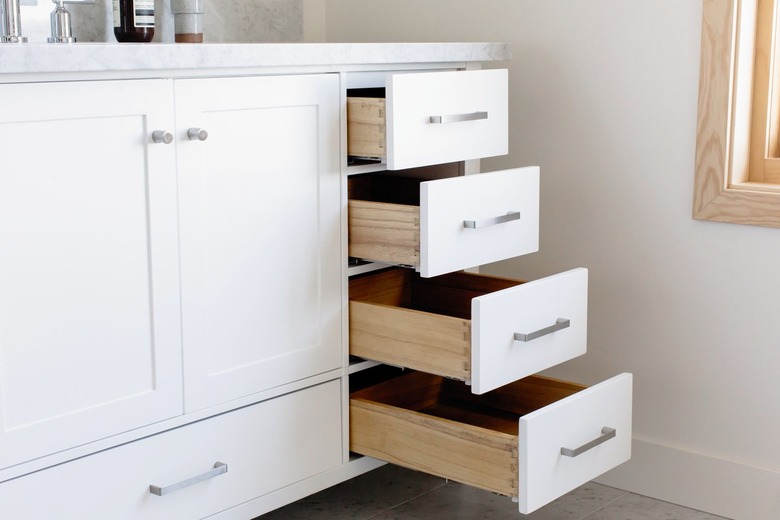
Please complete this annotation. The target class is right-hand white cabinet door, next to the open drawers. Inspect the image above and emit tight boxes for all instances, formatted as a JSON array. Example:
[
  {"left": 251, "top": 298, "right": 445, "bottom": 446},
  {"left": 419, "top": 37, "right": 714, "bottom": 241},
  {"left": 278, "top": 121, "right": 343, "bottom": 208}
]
[{"left": 176, "top": 75, "right": 342, "bottom": 411}]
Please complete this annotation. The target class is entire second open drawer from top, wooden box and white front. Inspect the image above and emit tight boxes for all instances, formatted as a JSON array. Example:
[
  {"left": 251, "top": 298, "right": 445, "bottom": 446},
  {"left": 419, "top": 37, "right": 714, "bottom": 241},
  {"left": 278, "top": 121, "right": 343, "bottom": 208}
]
[{"left": 348, "top": 166, "right": 539, "bottom": 277}]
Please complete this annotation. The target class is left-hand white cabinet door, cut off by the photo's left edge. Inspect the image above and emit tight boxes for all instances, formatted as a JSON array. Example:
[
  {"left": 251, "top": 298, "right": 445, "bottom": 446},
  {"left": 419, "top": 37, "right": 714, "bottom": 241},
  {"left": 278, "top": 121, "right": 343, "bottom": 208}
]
[{"left": 0, "top": 80, "right": 182, "bottom": 467}]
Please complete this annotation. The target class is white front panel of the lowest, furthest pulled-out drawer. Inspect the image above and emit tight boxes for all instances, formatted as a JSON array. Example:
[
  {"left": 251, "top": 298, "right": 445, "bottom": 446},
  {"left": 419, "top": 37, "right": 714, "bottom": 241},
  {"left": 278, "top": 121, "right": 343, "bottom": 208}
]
[{"left": 519, "top": 374, "right": 633, "bottom": 514}]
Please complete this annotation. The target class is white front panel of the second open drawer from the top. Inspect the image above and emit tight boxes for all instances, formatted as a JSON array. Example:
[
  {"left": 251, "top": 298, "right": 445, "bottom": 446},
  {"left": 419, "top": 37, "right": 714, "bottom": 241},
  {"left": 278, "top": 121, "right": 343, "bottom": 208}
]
[{"left": 420, "top": 166, "right": 539, "bottom": 277}]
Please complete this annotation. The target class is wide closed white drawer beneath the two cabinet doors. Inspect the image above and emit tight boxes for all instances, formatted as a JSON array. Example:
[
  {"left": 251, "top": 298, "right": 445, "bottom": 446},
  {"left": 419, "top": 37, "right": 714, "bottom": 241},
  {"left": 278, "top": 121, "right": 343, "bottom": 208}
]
[{"left": 0, "top": 381, "right": 342, "bottom": 520}]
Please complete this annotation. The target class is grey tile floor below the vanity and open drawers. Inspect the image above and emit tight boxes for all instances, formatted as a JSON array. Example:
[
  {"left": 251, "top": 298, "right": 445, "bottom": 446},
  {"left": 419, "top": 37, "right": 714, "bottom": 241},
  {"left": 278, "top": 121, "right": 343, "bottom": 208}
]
[{"left": 257, "top": 465, "right": 724, "bottom": 520}]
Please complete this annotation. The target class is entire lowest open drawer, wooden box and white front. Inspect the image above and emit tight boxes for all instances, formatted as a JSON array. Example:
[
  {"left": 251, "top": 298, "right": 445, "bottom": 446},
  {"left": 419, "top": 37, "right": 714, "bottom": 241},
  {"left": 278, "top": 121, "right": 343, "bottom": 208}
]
[{"left": 350, "top": 372, "right": 632, "bottom": 514}]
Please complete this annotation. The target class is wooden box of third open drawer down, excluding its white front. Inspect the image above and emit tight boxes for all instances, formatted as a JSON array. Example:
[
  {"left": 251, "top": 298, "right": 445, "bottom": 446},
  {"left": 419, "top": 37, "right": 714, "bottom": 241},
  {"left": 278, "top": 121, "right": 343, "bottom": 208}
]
[{"left": 349, "top": 268, "right": 532, "bottom": 381}]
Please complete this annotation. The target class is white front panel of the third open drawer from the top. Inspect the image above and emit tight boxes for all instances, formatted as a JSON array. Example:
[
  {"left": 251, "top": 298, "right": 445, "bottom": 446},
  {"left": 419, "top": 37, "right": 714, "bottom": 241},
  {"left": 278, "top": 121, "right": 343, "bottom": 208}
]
[{"left": 471, "top": 268, "right": 588, "bottom": 394}]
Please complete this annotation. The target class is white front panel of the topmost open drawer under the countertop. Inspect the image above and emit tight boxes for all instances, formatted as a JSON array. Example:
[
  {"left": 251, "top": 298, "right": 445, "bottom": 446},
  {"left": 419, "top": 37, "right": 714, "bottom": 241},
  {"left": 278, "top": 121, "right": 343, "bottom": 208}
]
[{"left": 386, "top": 69, "right": 508, "bottom": 170}]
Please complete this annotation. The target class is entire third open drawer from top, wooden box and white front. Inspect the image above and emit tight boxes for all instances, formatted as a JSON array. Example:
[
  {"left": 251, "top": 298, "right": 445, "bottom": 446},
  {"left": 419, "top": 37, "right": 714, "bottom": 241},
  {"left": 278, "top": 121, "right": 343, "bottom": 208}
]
[{"left": 349, "top": 268, "right": 588, "bottom": 394}]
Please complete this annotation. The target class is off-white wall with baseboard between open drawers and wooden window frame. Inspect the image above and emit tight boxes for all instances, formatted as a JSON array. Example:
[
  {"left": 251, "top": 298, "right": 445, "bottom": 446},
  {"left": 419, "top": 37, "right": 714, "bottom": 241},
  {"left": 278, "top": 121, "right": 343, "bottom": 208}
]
[{"left": 326, "top": 0, "right": 780, "bottom": 520}]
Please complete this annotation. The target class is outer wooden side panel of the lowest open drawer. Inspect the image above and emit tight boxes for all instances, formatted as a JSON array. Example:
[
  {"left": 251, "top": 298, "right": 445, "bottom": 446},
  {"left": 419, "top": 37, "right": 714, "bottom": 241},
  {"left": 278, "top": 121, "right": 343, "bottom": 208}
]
[{"left": 350, "top": 399, "right": 518, "bottom": 497}]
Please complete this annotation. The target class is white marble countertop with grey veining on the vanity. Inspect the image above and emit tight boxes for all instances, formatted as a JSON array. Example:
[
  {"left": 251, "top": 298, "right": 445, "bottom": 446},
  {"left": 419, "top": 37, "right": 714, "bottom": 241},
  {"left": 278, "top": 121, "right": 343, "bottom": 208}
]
[{"left": 0, "top": 42, "right": 511, "bottom": 80}]
